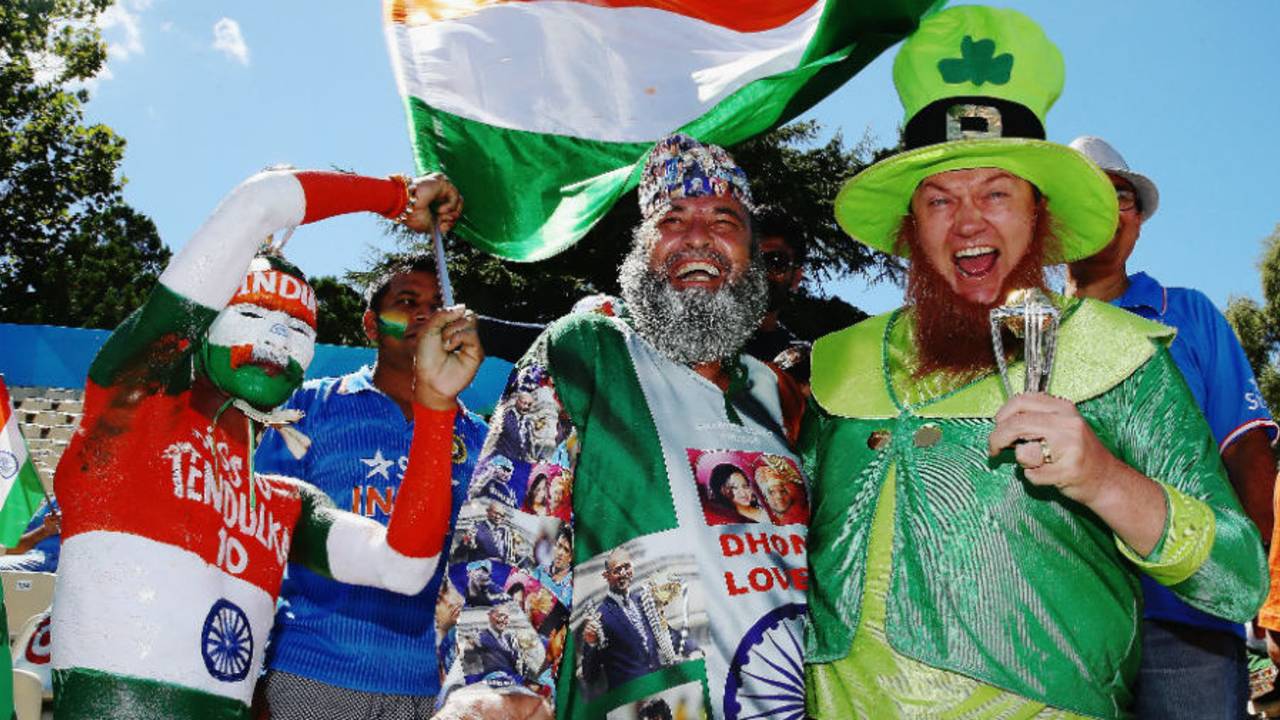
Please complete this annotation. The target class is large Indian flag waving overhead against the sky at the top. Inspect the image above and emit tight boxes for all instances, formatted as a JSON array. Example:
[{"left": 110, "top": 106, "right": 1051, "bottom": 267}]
[{"left": 384, "top": 0, "right": 943, "bottom": 261}]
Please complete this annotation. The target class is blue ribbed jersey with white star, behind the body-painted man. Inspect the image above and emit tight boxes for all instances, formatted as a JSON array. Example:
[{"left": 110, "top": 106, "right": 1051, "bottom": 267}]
[{"left": 253, "top": 366, "right": 488, "bottom": 696}]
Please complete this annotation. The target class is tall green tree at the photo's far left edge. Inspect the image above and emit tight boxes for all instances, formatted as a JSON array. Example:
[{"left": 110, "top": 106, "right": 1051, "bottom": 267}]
[{"left": 0, "top": 0, "right": 169, "bottom": 327}]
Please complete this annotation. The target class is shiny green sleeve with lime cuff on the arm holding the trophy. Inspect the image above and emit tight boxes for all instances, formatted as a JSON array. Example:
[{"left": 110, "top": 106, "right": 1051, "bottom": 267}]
[{"left": 1082, "top": 346, "right": 1267, "bottom": 623}]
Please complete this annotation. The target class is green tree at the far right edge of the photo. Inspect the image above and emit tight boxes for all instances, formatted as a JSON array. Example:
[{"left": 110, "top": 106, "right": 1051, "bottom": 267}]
[{"left": 1226, "top": 224, "right": 1280, "bottom": 413}]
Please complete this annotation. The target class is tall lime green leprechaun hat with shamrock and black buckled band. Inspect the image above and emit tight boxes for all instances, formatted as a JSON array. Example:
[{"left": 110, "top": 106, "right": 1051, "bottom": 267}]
[{"left": 836, "top": 5, "right": 1117, "bottom": 264}]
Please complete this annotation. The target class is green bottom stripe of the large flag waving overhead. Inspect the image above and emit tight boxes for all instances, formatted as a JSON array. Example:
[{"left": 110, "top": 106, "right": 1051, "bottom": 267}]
[{"left": 406, "top": 0, "right": 945, "bottom": 261}]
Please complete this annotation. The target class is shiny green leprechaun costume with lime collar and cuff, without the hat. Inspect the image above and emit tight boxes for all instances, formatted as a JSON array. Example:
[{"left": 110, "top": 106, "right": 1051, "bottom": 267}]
[{"left": 801, "top": 299, "right": 1267, "bottom": 717}]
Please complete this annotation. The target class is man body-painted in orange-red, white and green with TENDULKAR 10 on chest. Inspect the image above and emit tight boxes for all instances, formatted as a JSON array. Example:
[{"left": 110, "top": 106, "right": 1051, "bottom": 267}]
[{"left": 52, "top": 172, "right": 480, "bottom": 719}]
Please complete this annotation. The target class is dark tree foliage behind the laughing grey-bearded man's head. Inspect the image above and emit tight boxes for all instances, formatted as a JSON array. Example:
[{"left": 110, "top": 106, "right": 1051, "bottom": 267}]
[{"left": 332, "top": 120, "right": 897, "bottom": 337}]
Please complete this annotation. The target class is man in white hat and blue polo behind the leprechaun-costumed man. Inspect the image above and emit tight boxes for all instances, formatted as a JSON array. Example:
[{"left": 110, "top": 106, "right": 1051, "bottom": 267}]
[{"left": 1066, "top": 136, "right": 1280, "bottom": 717}]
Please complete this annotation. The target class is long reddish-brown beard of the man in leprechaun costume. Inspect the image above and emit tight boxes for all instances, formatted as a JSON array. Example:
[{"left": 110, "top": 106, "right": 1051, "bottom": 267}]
[{"left": 899, "top": 211, "right": 1056, "bottom": 378}]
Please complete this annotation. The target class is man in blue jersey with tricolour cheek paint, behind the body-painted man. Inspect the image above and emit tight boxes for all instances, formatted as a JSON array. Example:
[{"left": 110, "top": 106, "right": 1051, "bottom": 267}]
[{"left": 255, "top": 254, "right": 485, "bottom": 720}]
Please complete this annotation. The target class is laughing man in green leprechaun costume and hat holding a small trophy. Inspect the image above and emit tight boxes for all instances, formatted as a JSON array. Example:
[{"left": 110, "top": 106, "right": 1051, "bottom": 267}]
[{"left": 800, "top": 6, "right": 1267, "bottom": 719}]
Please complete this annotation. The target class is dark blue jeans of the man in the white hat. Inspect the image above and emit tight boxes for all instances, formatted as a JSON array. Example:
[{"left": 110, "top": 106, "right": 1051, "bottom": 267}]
[{"left": 1134, "top": 620, "right": 1249, "bottom": 720}]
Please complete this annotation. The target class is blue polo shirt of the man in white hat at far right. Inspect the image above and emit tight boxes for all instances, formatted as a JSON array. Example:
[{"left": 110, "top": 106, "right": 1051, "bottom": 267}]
[{"left": 1111, "top": 273, "right": 1277, "bottom": 637}]
